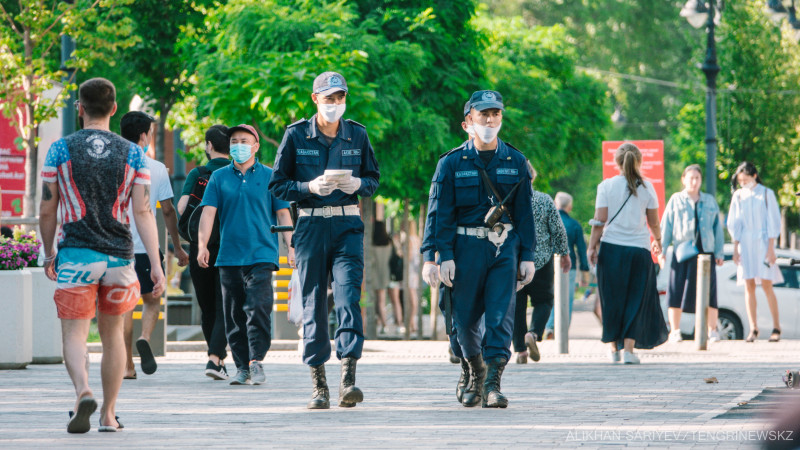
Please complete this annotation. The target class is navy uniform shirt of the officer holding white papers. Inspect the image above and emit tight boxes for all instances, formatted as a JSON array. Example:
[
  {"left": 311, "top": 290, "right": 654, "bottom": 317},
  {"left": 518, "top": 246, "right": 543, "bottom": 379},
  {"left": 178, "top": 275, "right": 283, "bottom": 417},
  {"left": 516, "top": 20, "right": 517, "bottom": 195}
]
[{"left": 269, "top": 114, "right": 380, "bottom": 208}]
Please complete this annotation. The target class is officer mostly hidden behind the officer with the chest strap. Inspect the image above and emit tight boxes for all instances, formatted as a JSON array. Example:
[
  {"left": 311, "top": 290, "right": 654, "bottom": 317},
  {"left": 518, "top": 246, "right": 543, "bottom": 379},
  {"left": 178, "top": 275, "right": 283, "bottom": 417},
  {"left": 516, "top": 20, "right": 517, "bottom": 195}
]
[{"left": 419, "top": 100, "right": 472, "bottom": 403}]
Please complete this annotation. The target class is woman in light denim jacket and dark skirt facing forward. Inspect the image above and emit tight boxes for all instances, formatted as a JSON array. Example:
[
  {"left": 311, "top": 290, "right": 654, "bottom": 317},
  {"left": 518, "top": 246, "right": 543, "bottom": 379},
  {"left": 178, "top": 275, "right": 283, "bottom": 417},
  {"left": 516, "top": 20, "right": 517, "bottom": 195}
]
[{"left": 660, "top": 164, "right": 725, "bottom": 342}]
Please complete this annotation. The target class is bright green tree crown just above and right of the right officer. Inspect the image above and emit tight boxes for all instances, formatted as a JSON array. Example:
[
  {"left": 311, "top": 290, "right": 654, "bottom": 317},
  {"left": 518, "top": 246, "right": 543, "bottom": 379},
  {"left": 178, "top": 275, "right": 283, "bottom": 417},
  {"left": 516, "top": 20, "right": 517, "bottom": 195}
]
[{"left": 476, "top": 16, "right": 610, "bottom": 190}]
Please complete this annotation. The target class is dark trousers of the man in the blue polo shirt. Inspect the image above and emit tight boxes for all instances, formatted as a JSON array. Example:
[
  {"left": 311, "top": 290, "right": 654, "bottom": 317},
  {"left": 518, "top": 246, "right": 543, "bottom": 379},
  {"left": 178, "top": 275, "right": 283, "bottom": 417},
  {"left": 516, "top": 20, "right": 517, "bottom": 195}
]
[{"left": 219, "top": 263, "right": 276, "bottom": 370}]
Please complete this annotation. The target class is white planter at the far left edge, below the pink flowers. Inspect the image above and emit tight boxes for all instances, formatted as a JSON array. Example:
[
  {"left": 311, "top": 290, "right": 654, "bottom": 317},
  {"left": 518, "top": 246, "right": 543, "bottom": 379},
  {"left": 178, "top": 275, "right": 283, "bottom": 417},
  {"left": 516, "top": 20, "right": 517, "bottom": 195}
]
[{"left": 0, "top": 269, "right": 33, "bottom": 370}]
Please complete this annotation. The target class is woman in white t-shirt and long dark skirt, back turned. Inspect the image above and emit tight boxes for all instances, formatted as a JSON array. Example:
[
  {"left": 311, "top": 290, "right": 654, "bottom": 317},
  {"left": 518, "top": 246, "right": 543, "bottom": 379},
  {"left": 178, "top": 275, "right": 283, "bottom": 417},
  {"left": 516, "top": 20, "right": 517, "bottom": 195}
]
[{"left": 587, "top": 142, "right": 667, "bottom": 364}]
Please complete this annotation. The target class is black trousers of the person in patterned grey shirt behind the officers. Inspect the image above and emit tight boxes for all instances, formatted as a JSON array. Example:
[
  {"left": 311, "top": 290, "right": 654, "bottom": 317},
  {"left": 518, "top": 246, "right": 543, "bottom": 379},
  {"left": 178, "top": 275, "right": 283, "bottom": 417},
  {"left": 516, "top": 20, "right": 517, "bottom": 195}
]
[{"left": 513, "top": 257, "right": 555, "bottom": 352}]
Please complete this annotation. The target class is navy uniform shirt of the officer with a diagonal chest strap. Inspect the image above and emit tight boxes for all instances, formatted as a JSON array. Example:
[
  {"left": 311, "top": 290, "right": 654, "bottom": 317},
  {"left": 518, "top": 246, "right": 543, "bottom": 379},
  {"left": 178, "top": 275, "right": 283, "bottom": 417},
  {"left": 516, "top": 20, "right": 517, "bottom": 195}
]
[{"left": 434, "top": 139, "right": 536, "bottom": 261}]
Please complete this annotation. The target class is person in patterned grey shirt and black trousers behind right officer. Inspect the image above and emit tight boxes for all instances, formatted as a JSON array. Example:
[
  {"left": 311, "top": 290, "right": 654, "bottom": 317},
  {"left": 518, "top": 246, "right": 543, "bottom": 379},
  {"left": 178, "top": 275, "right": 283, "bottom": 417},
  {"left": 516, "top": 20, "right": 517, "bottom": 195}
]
[{"left": 513, "top": 181, "right": 572, "bottom": 364}]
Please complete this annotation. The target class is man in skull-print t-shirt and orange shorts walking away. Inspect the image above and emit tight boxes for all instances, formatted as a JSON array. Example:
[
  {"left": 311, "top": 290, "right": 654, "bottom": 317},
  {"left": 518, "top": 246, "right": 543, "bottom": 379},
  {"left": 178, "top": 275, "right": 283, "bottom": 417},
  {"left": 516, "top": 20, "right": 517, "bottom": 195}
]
[{"left": 39, "top": 78, "right": 164, "bottom": 433}]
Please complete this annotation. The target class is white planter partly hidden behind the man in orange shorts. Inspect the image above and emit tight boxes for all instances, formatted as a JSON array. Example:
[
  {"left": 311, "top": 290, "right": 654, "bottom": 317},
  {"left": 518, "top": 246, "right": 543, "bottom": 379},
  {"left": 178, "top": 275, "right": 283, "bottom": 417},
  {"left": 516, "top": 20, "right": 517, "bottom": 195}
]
[{"left": 26, "top": 267, "right": 64, "bottom": 364}]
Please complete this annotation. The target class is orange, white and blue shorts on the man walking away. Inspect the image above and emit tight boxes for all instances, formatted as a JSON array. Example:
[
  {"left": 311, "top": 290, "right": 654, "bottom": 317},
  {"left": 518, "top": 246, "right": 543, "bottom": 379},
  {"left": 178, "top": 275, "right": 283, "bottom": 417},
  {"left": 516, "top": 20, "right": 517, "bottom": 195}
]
[{"left": 54, "top": 248, "right": 139, "bottom": 319}]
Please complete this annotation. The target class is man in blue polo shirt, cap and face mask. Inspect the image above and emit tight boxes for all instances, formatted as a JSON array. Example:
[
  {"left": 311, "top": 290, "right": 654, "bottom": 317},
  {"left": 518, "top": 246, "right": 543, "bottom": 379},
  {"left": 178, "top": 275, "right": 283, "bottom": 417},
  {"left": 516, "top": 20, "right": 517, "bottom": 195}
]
[{"left": 197, "top": 125, "right": 294, "bottom": 385}]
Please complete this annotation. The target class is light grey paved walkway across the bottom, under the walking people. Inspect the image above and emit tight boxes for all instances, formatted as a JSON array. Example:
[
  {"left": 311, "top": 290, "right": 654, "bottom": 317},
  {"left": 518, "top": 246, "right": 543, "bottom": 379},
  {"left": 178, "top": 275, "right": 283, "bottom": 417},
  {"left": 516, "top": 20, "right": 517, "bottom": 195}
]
[{"left": 0, "top": 312, "right": 800, "bottom": 449}]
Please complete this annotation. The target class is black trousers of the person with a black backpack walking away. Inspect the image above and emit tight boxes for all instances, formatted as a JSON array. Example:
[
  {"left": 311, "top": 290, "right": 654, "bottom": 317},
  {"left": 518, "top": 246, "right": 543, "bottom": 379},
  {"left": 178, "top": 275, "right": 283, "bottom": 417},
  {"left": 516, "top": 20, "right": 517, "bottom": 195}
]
[{"left": 189, "top": 243, "right": 228, "bottom": 359}]
